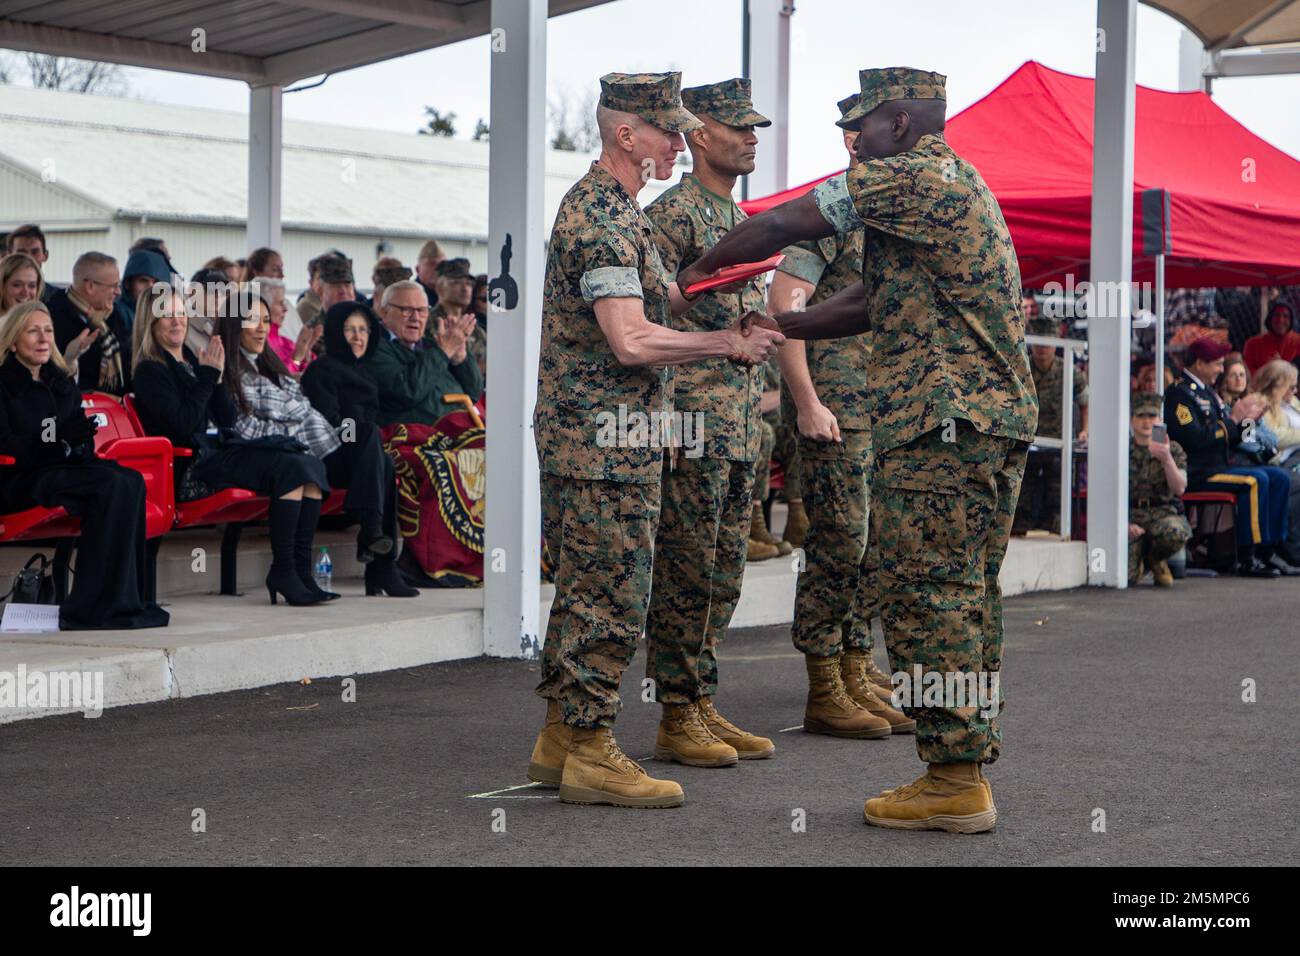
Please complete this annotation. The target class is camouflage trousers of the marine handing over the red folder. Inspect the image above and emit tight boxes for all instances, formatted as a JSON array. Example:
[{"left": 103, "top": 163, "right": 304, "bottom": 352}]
[{"left": 871, "top": 421, "right": 1028, "bottom": 763}]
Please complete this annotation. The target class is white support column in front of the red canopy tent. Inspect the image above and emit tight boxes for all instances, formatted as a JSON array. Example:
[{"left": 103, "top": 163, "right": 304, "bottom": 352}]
[{"left": 1088, "top": 0, "right": 1138, "bottom": 588}]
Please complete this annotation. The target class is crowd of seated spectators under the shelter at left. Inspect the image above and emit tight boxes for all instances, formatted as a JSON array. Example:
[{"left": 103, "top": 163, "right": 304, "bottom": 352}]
[{"left": 0, "top": 225, "right": 486, "bottom": 628}]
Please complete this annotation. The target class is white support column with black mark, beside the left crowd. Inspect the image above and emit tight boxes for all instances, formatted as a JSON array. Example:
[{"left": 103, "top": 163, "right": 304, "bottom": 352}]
[{"left": 484, "top": 0, "right": 546, "bottom": 657}]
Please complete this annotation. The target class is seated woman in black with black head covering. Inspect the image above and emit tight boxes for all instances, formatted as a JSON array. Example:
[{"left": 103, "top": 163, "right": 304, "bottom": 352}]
[{"left": 303, "top": 302, "right": 419, "bottom": 597}]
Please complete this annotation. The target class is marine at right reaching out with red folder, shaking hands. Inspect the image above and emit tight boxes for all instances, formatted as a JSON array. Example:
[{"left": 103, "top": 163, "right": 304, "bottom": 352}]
[{"left": 680, "top": 68, "right": 1037, "bottom": 832}]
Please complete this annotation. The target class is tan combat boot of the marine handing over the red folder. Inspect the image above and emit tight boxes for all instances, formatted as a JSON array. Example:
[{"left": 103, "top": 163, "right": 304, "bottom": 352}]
[{"left": 862, "top": 763, "right": 997, "bottom": 834}]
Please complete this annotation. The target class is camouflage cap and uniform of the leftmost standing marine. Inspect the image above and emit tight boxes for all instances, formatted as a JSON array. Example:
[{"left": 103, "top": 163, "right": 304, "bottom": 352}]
[{"left": 533, "top": 74, "right": 699, "bottom": 727}]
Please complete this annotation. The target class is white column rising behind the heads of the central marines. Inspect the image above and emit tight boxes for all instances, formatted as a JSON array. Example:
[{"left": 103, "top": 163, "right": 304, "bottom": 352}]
[{"left": 741, "top": 0, "right": 794, "bottom": 199}]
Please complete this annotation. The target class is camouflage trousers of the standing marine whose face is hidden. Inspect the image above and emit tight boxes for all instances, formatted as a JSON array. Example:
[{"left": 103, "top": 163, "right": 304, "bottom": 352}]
[{"left": 790, "top": 429, "right": 879, "bottom": 657}]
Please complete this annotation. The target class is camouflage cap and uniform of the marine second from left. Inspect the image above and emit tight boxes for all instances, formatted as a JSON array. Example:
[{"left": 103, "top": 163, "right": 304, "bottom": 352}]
[{"left": 646, "top": 79, "right": 771, "bottom": 704}]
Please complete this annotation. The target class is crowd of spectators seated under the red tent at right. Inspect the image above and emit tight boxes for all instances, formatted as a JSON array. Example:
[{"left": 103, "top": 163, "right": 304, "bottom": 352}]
[{"left": 1017, "top": 287, "right": 1300, "bottom": 585}]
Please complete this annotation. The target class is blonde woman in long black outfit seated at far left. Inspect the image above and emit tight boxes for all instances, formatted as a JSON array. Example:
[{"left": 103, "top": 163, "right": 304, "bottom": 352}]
[{"left": 0, "top": 299, "right": 168, "bottom": 631}]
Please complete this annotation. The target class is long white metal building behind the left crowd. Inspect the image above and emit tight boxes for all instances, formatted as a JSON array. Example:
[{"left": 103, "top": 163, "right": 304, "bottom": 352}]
[{"left": 0, "top": 86, "right": 670, "bottom": 287}]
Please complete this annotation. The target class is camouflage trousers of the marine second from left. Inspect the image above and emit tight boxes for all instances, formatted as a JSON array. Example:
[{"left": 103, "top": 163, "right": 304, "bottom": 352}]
[{"left": 646, "top": 455, "right": 754, "bottom": 704}]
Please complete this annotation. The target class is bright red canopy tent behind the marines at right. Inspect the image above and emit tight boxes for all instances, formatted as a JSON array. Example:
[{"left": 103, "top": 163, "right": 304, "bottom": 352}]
[{"left": 741, "top": 61, "right": 1300, "bottom": 287}]
